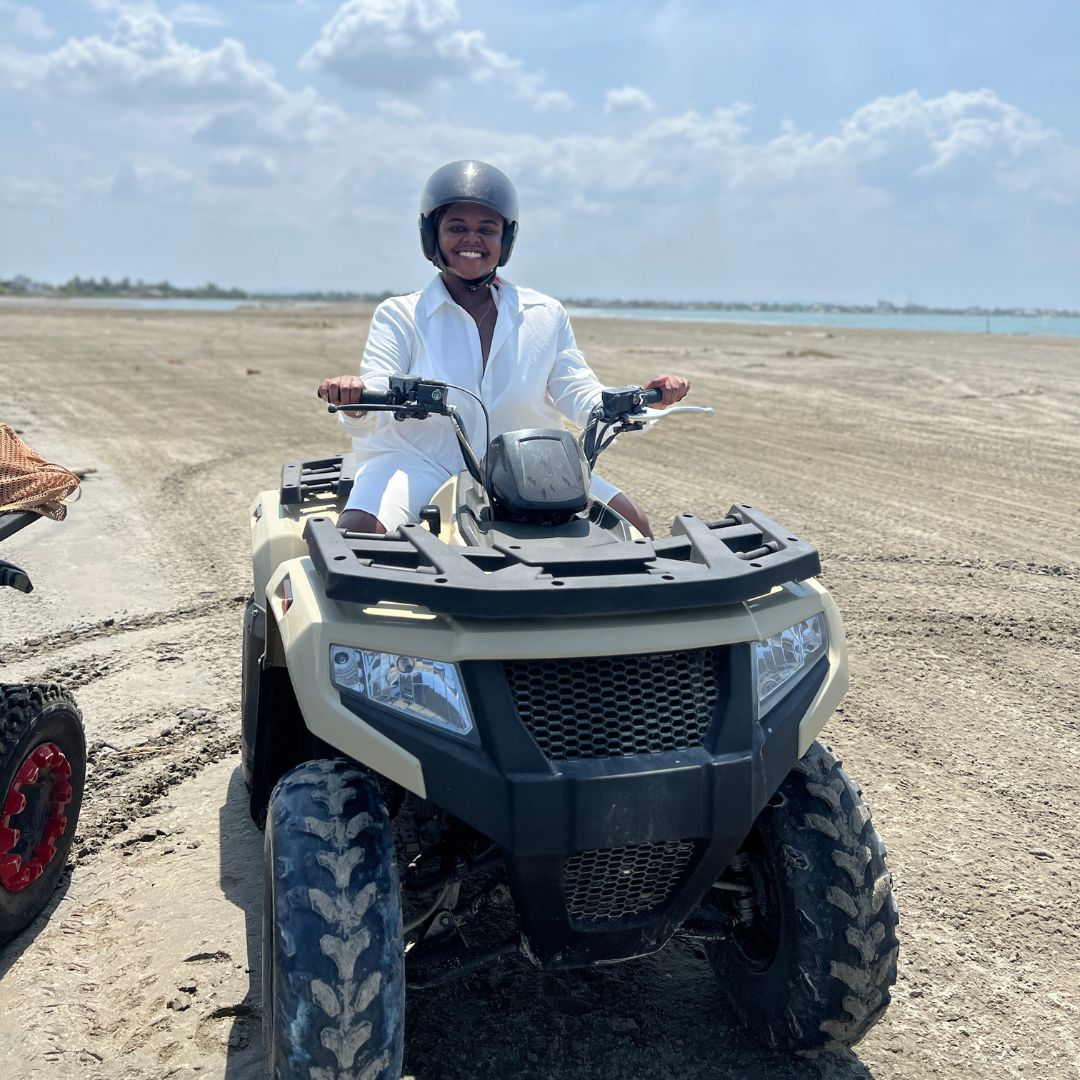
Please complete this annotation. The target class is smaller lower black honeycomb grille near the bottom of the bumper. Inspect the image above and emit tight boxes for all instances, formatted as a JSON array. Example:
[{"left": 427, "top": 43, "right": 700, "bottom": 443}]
[{"left": 563, "top": 840, "right": 696, "bottom": 929}]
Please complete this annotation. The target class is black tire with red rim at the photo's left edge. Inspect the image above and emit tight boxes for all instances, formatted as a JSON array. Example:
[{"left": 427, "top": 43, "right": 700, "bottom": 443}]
[{"left": 0, "top": 685, "right": 86, "bottom": 940}]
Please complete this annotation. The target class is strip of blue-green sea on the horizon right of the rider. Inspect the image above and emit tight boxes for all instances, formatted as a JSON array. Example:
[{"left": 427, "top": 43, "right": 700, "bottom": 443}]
[{"left": 567, "top": 307, "right": 1080, "bottom": 337}]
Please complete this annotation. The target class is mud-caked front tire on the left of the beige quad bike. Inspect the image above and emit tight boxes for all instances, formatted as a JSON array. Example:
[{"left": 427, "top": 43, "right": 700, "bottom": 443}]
[{"left": 262, "top": 759, "right": 405, "bottom": 1080}]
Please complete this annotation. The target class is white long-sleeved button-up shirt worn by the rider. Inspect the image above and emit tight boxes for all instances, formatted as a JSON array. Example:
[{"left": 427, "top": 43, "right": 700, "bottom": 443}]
[{"left": 337, "top": 278, "right": 603, "bottom": 475}]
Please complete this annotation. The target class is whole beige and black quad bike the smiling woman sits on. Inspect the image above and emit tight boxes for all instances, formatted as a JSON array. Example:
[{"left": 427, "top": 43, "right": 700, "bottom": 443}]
[{"left": 242, "top": 378, "right": 897, "bottom": 1080}]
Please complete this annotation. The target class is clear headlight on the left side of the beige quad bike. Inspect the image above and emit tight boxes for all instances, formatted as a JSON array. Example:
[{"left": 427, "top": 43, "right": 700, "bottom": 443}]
[{"left": 330, "top": 645, "right": 473, "bottom": 735}]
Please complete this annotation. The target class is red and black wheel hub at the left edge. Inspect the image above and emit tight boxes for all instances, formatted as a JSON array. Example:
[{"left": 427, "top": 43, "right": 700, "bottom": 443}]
[{"left": 0, "top": 742, "right": 71, "bottom": 892}]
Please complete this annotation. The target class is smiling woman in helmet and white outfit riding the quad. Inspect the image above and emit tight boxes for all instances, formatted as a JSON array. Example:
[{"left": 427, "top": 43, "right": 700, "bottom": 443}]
[{"left": 319, "top": 161, "right": 689, "bottom": 536}]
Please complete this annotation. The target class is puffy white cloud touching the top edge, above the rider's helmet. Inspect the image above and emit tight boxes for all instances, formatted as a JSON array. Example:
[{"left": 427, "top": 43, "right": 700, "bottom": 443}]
[{"left": 301, "top": 0, "right": 573, "bottom": 111}]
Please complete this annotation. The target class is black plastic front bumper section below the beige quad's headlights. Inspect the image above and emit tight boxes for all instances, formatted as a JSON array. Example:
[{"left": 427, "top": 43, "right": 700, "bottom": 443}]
[{"left": 342, "top": 630, "right": 828, "bottom": 968}]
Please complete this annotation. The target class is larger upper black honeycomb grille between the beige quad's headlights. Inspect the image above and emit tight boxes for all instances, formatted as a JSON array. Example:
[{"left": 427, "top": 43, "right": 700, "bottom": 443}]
[{"left": 504, "top": 648, "right": 724, "bottom": 761}]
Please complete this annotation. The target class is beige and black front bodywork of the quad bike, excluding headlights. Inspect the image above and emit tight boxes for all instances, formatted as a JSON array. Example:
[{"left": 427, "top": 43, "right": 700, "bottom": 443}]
[{"left": 266, "top": 558, "right": 847, "bottom": 967}]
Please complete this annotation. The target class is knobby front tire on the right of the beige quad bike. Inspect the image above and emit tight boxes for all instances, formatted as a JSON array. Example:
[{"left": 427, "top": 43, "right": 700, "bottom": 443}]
[{"left": 708, "top": 742, "right": 899, "bottom": 1050}]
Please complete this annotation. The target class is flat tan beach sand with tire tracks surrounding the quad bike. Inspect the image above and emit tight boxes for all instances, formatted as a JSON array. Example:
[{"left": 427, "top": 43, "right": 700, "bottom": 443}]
[{"left": 0, "top": 305, "right": 1080, "bottom": 1080}]
